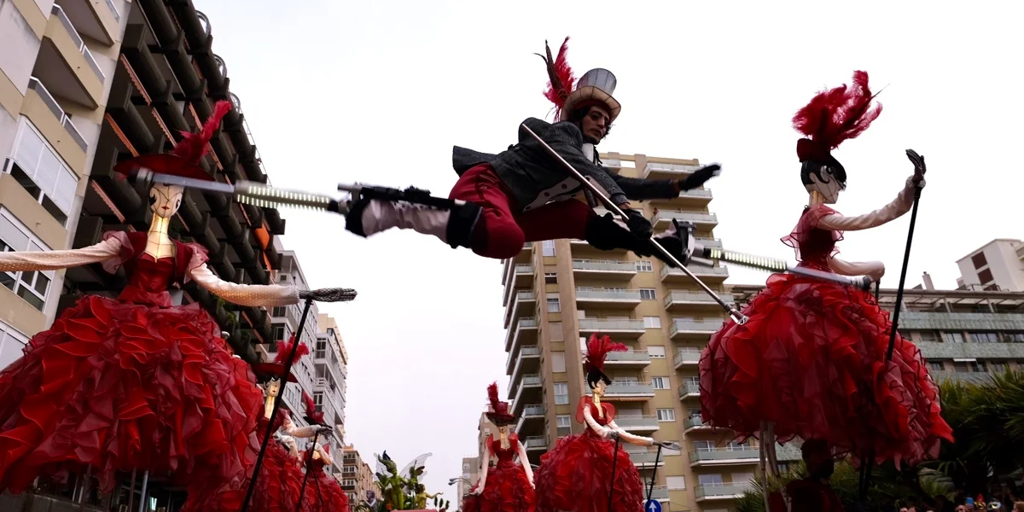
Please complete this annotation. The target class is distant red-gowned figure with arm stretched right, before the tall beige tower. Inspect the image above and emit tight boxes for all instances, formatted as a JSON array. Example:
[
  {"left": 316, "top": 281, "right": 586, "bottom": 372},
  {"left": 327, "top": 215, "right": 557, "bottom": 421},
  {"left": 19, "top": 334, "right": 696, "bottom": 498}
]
[{"left": 537, "top": 334, "right": 679, "bottom": 512}]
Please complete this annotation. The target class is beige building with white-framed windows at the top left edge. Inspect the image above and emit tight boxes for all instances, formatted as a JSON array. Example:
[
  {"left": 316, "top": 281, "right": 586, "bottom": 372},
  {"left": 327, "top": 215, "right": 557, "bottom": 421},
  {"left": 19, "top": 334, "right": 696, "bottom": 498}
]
[{"left": 0, "top": 0, "right": 130, "bottom": 368}]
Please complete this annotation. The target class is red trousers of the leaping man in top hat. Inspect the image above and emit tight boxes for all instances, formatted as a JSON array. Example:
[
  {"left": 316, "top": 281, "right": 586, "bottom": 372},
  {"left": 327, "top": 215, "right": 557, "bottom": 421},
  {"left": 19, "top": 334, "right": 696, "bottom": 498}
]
[{"left": 449, "top": 164, "right": 597, "bottom": 259}]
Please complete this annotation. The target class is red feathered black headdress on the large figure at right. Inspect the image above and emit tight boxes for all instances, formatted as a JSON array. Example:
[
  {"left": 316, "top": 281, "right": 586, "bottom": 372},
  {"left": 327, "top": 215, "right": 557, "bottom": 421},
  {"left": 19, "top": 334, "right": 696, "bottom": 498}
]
[{"left": 793, "top": 71, "right": 882, "bottom": 162}]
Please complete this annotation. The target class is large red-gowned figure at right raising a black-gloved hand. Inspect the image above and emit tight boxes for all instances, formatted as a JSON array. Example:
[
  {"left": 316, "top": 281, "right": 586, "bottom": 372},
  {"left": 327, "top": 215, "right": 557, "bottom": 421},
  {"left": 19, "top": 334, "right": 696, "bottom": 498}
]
[{"left": 699, "top": 72, "right": 952, "bottom": 491}]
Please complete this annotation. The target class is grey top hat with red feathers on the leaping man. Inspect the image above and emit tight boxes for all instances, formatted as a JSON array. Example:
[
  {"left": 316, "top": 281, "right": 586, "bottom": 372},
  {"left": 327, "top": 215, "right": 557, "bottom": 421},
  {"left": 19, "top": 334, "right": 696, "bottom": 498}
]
[{"left": 537, "top": 38, "right": 623, "bottom": 121}]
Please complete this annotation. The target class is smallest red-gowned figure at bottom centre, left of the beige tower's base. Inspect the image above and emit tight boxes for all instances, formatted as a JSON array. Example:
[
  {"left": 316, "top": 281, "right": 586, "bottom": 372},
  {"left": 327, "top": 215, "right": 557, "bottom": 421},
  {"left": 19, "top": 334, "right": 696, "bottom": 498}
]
[{"left": 462, "top": 383, "right": 537, "bottom": 512}]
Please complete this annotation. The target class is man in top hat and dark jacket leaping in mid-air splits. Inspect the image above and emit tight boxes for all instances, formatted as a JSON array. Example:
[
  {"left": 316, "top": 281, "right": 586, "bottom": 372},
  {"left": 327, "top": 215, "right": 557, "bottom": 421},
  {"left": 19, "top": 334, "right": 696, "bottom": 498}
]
[{"left": 345, "top": 38, "right": 719, "bottom": 259}]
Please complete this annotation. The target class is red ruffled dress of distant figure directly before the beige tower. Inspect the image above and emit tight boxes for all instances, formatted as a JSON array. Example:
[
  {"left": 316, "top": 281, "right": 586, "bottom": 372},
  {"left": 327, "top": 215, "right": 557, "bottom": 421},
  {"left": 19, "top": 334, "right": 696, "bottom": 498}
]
[{"left": 536, "top": 396, "right": 644, "bottom": 512}]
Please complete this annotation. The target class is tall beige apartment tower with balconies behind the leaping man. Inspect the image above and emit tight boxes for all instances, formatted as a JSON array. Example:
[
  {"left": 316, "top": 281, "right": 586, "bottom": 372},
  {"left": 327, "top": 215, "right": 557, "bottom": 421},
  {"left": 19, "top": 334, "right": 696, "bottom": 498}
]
[{"left": 503, "top": 154, "right": 799, "bottom": 512}]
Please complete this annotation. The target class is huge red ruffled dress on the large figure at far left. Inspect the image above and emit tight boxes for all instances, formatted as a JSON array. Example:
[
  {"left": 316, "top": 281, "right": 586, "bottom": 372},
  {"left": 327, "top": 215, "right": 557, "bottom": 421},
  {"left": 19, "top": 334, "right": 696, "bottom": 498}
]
[{"left": 0, "top": 231, "right": 263, "bottom": 493}]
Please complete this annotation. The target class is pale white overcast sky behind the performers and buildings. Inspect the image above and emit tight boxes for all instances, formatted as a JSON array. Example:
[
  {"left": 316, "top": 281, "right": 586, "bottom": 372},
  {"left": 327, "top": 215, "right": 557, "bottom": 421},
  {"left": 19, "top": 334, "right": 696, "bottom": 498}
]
[{"left": 194, "top": 0, "right": 1024, "bottom": 501}]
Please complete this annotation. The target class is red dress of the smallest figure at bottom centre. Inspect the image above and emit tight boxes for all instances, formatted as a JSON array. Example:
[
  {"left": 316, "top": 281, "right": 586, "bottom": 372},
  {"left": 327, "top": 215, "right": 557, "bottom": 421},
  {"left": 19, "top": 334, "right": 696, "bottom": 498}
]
[{"left": 462, "top": 432, "right": 537, "bottom": 512}]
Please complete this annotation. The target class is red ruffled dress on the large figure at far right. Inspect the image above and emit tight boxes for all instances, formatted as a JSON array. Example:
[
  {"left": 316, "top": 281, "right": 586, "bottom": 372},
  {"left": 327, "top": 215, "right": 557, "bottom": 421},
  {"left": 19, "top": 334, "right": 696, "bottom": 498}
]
[{"left": 699, "top": 205, "right": 952, "bottom": 464}]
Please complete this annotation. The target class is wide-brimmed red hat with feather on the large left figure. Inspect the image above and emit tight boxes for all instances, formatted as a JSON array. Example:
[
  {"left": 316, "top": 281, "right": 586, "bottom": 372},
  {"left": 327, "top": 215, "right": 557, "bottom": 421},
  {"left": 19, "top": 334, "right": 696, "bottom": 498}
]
[{"left": 114, "top": 101, "right": 231, "bottom": 181}]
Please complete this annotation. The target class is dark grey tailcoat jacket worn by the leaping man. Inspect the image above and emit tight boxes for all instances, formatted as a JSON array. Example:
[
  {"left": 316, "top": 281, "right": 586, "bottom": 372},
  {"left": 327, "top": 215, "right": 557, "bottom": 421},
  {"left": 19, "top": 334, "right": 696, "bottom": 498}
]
[{"left": 452, "top": 118, "right": 679, "bottom": 211}]
